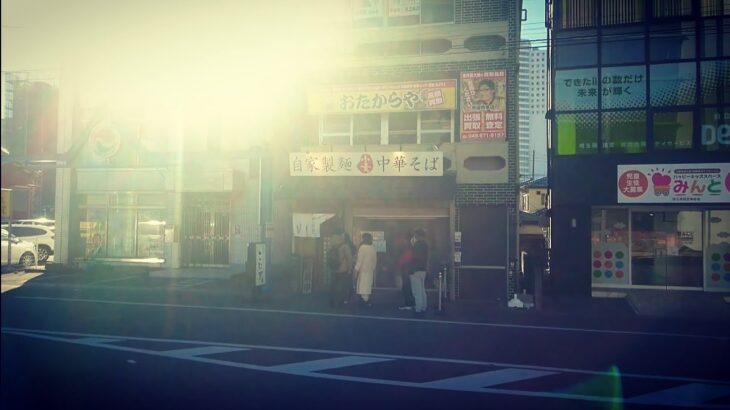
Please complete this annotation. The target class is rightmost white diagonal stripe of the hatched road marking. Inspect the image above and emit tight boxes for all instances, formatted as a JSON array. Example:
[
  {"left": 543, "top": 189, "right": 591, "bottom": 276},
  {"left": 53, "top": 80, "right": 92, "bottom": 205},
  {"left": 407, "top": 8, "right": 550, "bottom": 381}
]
[{"left": 627, "top": 383, "right": 730, "bottom": 407}]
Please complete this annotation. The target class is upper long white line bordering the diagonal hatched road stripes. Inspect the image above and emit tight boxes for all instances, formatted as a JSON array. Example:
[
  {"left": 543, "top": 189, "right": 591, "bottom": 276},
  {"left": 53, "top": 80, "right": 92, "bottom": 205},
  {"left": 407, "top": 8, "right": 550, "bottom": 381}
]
[{"left": 1, "top": 327, "right": 730, "bottom": 386}]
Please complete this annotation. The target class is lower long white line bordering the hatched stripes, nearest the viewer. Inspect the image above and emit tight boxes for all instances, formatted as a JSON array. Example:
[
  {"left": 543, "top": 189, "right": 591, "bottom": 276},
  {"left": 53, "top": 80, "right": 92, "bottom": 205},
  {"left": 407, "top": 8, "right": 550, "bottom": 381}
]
[{"left": 2, "top": 328, "right": 726, "bottom": 409}]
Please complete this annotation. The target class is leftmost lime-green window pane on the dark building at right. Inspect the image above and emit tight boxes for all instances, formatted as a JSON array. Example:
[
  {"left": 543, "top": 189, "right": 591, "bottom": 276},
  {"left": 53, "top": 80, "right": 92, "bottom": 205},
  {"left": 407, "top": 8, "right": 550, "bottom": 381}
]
[{"left": 555, "top": 113, "right": 598, "bottom": 155}]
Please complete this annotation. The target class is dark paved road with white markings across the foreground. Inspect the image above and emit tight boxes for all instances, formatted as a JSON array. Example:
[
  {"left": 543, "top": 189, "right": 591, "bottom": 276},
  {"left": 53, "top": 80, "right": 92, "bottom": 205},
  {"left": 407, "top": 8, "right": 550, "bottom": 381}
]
[{"left": 0, "top": 275, "right": 730, "bottom": 409}]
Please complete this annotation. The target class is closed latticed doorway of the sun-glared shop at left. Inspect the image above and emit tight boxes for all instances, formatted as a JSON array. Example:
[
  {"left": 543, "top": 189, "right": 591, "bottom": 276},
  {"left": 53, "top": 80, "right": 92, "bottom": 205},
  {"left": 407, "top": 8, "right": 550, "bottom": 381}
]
[{"left": 181, "top": 194, "right": 231, "bottom": 267}]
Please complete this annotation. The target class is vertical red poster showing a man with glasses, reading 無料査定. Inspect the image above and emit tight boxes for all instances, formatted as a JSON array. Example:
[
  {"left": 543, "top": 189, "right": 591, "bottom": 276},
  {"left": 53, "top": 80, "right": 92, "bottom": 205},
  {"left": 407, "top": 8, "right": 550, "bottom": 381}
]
[{"left": 461, "top": 70, "right": 507, "bottom": 141}]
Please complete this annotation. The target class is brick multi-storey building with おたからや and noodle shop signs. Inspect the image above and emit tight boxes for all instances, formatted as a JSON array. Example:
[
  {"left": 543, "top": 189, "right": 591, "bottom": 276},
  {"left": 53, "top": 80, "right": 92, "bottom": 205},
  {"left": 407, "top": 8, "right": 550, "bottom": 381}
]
[{"left": 272, "top": 0, "right": 520, "bottom": 301}]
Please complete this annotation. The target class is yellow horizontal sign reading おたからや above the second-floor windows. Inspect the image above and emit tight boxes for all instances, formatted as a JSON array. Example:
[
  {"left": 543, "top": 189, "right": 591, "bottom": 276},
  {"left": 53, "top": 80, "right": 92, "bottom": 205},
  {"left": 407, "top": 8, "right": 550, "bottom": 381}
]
[{"left": 309, "top": 80, "right": 456, "bottom": 114}]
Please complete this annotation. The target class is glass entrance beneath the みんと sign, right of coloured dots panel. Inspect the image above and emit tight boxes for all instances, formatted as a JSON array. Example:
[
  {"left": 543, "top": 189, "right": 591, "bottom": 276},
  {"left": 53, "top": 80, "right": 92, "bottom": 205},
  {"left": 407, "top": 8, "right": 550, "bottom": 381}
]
[{"left": 631, "top": 211, "right": 704, "bottom": 288}]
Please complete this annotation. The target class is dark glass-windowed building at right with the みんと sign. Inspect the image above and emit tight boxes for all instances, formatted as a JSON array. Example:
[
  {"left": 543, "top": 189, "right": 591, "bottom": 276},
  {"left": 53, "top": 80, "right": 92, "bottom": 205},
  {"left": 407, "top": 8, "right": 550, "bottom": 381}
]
[{"left": 548, "top": 0, "right": 730, "bottom": 295}]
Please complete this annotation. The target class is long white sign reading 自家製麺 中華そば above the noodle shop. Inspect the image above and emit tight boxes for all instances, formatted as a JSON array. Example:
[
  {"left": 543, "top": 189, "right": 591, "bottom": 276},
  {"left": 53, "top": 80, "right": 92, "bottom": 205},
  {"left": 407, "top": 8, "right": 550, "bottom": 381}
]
[{"left": 289, "top": 151, "right": 444, "bottom": 177}]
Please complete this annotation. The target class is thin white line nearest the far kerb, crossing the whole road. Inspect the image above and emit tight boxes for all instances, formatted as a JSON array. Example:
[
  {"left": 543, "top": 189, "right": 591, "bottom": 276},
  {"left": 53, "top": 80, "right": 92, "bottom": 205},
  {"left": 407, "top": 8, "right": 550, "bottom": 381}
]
[{"left": 15, "top": 296, "right": 730, "bottom": 341}]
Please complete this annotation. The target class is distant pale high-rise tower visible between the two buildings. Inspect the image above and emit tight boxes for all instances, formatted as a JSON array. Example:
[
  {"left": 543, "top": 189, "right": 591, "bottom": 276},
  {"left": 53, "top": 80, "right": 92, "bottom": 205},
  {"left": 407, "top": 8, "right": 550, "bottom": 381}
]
[{"left": 518, "top": 41, "right": 548, "bottom": 182}]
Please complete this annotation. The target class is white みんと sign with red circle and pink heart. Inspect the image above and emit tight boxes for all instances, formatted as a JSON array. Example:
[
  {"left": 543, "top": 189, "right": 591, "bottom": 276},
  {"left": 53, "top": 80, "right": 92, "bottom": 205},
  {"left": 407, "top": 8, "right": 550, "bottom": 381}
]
[{"left": 617, "top": 163, "right": 730, "bottom": 203}]
